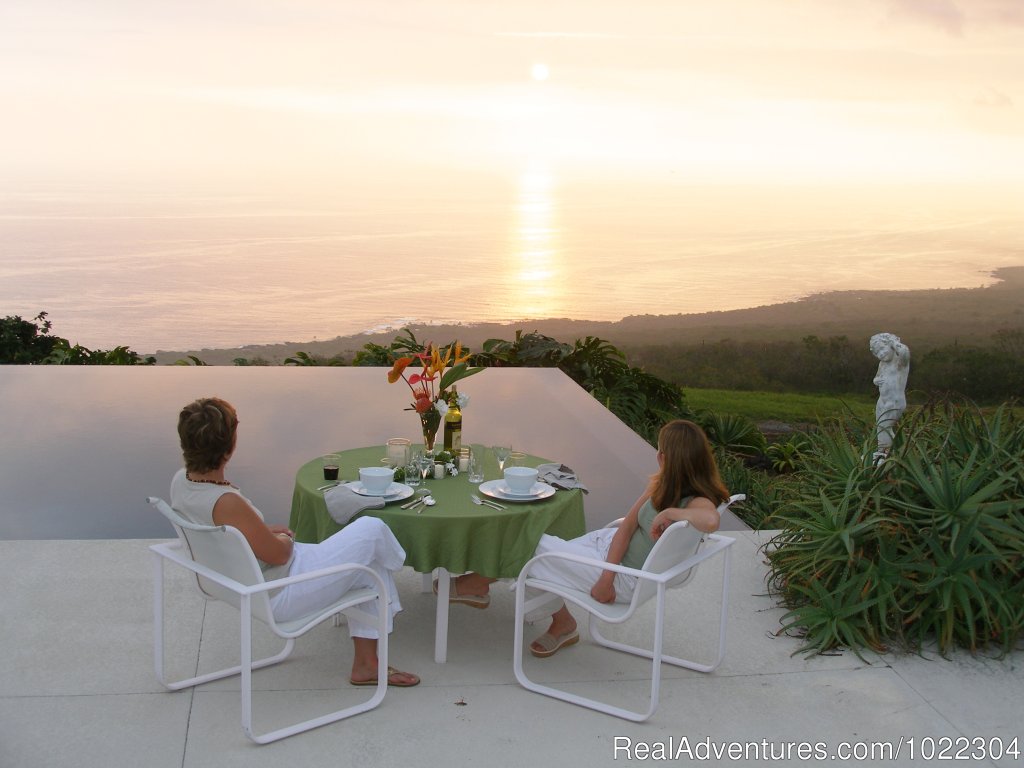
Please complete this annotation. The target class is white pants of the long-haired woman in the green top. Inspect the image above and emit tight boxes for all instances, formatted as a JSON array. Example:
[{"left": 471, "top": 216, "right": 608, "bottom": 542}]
[{"left": 526, "top": 528, "right": 637, "bottom": 622}]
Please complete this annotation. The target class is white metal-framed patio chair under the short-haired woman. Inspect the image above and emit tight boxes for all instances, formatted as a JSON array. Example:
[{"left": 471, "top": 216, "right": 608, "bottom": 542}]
[{"left": 147, "top": 497, "right": 388, "bottom": 744}]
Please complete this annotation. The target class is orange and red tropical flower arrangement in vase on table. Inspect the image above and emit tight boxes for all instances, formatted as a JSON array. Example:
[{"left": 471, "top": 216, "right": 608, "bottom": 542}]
[{"left": 387, "top": 341, "right": 483, "bottom": 451}]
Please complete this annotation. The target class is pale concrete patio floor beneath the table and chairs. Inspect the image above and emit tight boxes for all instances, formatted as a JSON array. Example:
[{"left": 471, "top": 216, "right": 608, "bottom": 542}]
[{"left": 0, "top": 531, "right": 1024, "bottom": 768}]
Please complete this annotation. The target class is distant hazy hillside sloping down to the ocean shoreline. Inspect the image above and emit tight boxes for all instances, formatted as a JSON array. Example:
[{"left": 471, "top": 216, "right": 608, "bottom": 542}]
[{"left": 156, "top": 266, "right": 1024, "bottom": 366}]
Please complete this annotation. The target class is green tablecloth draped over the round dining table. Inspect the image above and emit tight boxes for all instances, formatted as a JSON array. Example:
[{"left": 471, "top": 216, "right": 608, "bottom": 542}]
[{"left": 289, "top": 445, "right": 586, "bottom": 579}]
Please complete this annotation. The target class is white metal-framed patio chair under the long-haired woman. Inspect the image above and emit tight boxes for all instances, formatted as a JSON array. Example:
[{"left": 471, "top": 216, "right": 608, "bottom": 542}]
[{"left": 513, "top": 494, "right": 746, "bottom": 722}]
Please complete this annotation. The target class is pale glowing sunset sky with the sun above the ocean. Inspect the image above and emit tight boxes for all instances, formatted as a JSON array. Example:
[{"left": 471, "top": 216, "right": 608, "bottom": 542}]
[{"left": 0, "top": 0, "right": 1024, "bottom": 199}]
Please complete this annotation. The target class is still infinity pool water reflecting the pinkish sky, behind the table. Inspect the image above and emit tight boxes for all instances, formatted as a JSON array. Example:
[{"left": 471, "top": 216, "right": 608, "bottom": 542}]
[{"left": 0, "top": 366, "right": 657, "bottom": 540}]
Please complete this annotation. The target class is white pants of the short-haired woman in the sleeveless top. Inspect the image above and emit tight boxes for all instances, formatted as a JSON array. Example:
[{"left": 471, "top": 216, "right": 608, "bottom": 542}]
[{"left": 270, "top": 517, "right": 406, "bottom": 639}]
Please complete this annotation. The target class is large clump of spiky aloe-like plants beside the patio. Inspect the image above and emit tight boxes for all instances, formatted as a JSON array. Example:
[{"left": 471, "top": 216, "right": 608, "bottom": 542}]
[{"left": 766, "top": 399, "right": 1024, "bottom": 653}]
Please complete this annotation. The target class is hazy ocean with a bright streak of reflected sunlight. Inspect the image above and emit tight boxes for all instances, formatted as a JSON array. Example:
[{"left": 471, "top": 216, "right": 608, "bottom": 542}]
[{"left": 0, "top": 178, "right": 1024, "bottom": 353}]
